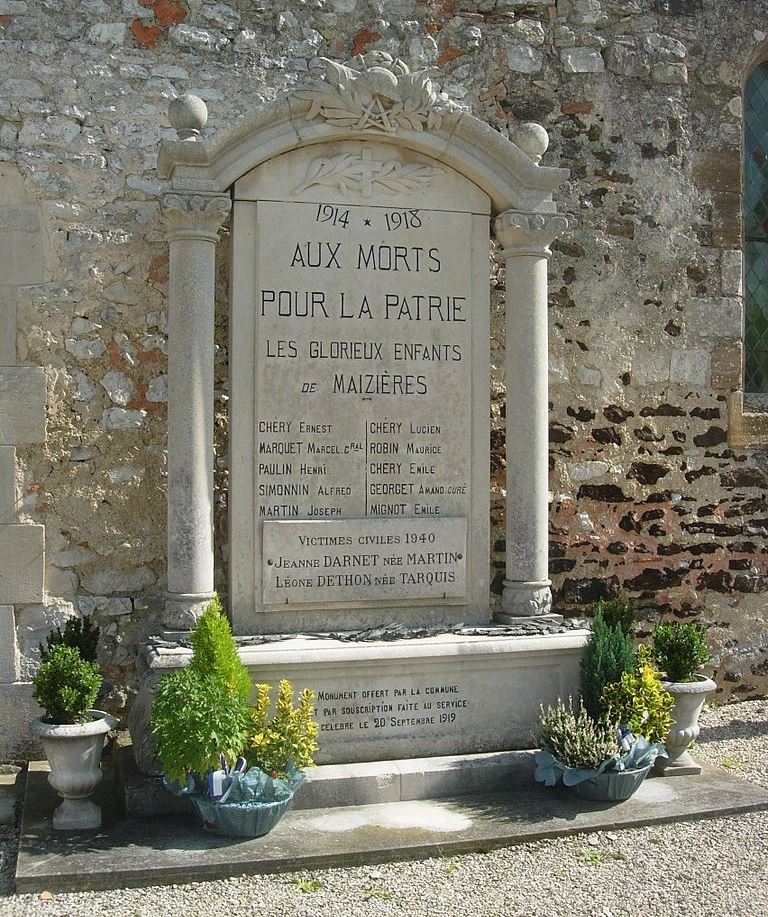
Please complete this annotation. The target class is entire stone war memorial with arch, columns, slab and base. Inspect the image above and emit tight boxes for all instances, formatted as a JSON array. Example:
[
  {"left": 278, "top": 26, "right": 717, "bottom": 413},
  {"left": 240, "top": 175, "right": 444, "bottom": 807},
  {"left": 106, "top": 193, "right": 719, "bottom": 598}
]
[{"left": 132, "top": 52, "right": 584, "bottom": 769}]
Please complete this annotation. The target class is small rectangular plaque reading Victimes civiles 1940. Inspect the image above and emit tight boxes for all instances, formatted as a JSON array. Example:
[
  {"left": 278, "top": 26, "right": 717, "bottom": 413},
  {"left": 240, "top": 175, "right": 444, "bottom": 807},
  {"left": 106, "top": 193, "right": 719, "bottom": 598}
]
[{"left": 262, "top": 517, "right": 467, "bottom": 605}]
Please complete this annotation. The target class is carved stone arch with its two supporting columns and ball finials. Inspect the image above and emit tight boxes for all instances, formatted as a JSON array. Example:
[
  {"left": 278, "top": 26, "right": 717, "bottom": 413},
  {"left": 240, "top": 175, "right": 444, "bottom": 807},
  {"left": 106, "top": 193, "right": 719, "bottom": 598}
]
[{"left": 158, "top": 52, "right": 568, "bottom": 630}]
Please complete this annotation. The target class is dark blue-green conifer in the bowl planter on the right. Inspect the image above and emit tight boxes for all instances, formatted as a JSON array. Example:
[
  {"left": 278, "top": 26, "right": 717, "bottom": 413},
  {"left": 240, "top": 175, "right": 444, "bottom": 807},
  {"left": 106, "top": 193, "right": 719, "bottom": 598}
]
[{"left": 580, "top": 603, "right": 635, "bottom": 720}]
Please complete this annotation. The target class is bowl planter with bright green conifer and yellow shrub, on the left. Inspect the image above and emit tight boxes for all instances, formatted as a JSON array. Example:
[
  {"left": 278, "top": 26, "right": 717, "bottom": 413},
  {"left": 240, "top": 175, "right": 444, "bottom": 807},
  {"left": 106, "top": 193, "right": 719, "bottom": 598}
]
[{"left": 150, "top": 599, "right": 317, "bottom": 837}]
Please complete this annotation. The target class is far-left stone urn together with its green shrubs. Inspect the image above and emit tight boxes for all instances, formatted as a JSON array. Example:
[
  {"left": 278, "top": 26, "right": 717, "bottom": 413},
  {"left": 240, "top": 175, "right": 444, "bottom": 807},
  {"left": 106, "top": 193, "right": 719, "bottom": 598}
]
[{"left": 31, "top": 621, "right": 117, "bottom": 831}]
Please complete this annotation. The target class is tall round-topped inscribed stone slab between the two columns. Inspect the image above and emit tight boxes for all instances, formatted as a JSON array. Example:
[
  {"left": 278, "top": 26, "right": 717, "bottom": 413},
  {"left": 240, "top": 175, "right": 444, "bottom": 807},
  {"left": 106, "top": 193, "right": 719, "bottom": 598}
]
[{"left": 230, "top": 141, "right": 489, "bottom": 632}]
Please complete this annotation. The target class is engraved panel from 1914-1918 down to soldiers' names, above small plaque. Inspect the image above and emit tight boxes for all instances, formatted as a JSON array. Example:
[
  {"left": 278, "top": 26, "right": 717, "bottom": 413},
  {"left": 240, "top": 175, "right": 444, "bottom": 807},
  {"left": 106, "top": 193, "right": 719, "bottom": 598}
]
[{"left": 254, "top": 201, "right": 472, "bottom": 522}]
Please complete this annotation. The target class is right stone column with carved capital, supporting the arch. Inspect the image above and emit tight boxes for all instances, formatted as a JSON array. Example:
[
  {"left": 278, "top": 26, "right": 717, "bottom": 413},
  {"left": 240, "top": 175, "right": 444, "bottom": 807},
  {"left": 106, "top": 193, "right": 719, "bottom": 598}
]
[{"left": 494, "top": 210, "right": 568, "bottom": 623}]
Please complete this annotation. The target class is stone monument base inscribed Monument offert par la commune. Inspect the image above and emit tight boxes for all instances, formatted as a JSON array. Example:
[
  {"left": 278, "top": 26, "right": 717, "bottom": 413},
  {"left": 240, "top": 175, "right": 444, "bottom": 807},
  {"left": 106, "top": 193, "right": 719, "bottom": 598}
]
[{"left": 129, "top": 625, "right": 588, "bottom": 774}]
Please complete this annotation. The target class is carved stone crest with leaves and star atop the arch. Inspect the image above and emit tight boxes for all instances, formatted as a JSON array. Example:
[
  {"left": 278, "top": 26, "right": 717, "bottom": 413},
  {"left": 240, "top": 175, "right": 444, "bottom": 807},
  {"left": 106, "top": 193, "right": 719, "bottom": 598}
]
[{"left": 296, "top": 51, "right": 455, "bottom": 134}]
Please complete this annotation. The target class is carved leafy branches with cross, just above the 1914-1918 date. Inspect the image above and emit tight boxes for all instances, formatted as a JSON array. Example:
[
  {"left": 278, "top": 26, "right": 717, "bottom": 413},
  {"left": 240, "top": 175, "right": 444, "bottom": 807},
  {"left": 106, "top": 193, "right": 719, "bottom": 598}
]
[{"left": 293, "top": 153, "right": 442, "bottom": 194}]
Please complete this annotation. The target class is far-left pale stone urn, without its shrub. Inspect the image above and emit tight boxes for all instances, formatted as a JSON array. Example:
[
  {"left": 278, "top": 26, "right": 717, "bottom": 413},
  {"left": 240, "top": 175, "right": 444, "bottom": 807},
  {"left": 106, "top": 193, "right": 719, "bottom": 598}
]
[{"left": 30, "top": 710, "right": 117, "bottom": 831}]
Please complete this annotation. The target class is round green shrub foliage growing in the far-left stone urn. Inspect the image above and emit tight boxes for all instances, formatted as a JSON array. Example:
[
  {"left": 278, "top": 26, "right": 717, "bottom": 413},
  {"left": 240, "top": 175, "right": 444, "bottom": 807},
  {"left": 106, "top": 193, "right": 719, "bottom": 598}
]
[{"left": 32, "top": 643, "right": 101, "bottom": 725}]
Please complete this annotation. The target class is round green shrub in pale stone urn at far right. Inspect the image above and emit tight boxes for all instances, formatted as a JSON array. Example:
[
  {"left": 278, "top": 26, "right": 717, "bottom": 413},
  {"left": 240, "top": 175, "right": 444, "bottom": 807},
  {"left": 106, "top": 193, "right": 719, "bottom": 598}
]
[{"left": 652, "top": 621, "right": 717, "bottom": 776}]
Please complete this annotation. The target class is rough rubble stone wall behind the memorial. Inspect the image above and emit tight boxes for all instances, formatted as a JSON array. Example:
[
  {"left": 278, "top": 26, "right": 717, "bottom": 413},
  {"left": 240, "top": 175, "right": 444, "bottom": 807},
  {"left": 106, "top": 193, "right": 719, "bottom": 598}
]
[{"left": 0, "top": 0, "right": 768, "bottom": 756}]
